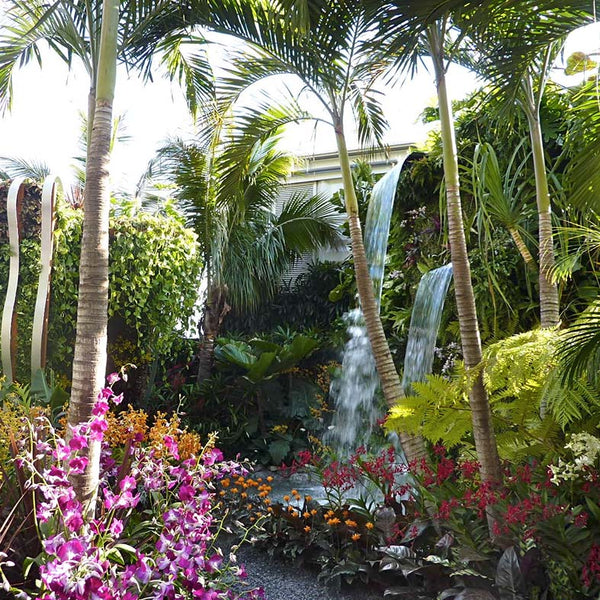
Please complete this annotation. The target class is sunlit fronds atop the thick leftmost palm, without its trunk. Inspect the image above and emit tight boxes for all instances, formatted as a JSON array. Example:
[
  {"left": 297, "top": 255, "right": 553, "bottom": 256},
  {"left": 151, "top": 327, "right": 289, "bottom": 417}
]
[{"left": 0, "top": 0, "right": 214, "bottom": 113}]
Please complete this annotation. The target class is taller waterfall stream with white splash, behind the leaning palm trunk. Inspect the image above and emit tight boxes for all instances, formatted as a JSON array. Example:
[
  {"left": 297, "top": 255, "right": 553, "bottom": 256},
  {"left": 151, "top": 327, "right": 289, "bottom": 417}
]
[{"left": 324, "top": 161, "right": 404, "bottom": 456}]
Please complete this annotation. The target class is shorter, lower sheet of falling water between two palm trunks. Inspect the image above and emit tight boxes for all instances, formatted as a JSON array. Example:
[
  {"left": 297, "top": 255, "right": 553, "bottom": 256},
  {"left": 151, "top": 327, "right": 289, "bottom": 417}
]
[{"left": 402, "top": 264, "right": 452, "bottom": 394}]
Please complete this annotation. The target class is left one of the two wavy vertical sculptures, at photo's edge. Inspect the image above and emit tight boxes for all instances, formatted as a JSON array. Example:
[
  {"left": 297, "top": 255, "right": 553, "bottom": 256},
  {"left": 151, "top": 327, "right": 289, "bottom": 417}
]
[{"left": 1, "top": 177, "right": 25, "bottom": 382}]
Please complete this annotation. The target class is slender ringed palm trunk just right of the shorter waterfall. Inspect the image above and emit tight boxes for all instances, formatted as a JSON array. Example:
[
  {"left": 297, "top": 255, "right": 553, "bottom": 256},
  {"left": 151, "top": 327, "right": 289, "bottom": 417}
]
[{"left": 428, "top": 25, "right": 502, "bottom": 483}]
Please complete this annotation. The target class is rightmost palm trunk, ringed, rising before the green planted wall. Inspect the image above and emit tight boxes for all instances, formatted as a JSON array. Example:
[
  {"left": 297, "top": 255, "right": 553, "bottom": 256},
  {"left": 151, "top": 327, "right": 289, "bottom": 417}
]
[{"left": 523, "top": 79, "right": 560, "bottom": 328}]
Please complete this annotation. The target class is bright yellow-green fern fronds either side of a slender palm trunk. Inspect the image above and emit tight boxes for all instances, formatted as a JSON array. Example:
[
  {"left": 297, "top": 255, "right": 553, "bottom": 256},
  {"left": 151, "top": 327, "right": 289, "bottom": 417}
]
[{"left": 386, "top": 330, "right": 584, "bottom": 459}]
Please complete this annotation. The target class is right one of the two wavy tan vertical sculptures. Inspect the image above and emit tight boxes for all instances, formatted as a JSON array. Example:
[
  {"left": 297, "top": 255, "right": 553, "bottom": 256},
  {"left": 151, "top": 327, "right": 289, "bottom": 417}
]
[{"left": 31, "top": 175, "right": 62, "bottom": 380}]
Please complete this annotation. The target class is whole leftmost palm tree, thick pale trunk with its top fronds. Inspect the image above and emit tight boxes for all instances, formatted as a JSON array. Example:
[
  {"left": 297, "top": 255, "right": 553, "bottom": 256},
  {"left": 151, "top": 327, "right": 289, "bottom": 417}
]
[{"left": 0, "top": 0, "right": 212, "bottom": 509}]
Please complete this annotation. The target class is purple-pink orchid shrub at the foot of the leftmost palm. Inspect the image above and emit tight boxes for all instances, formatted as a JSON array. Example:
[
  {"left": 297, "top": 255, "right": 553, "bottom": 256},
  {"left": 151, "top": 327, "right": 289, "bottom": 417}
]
[{"left": 0, "top": 377, "right": 262, "bottom": 600}]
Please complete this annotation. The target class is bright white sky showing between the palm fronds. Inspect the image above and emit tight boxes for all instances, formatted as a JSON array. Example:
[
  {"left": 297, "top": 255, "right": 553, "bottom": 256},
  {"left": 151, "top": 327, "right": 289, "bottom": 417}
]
[{"left": 0, "top": 19, "right": 600, "bottom": 192}]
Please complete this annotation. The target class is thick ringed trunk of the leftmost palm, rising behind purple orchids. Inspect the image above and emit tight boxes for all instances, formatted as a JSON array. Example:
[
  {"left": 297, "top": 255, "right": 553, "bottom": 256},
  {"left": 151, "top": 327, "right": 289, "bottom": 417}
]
[{"left": 68, "top": 0, "right": 119, "bottom": 514}]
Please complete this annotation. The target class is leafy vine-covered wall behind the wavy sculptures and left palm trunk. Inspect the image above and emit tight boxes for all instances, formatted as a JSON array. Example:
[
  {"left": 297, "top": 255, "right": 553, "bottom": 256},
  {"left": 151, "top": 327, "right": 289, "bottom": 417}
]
[{"left": 0, "top": 199, "right": 201, "bottom": 381}]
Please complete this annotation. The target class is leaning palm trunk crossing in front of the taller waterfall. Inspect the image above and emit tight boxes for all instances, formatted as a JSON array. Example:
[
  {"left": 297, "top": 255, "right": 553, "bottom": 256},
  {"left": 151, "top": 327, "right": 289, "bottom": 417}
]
[{"left": 335, "top": 118, "right": 425, "bottom": 462}]
